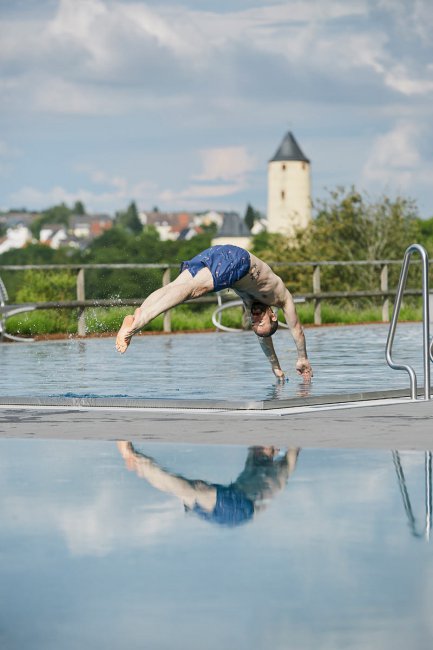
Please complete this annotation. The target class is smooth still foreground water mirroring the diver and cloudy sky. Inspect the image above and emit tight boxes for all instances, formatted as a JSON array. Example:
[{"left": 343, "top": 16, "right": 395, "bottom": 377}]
[{"left": 0, "top": 440, "right": 433, "bottom": 650}]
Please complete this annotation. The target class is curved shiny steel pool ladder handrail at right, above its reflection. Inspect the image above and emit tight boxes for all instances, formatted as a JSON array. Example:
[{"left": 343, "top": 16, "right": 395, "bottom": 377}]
[{"left": 385, "top": 244, "right": 433, "bottom": 400}]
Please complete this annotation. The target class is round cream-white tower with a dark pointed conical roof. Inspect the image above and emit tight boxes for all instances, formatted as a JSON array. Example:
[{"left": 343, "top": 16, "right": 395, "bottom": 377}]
[{"left": 267, "top": 131, "right": 311, "bottom": 237}]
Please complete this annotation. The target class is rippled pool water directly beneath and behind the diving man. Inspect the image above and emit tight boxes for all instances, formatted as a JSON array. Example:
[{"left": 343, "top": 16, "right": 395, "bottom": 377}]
[{"left": 0, "top": 323, "right": 423, "bottom": 401}]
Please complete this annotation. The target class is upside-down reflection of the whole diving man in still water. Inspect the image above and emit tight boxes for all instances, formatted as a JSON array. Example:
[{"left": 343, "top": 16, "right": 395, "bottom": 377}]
[{"left": 117, "top": 441, "right": 299, "bottom": 526}]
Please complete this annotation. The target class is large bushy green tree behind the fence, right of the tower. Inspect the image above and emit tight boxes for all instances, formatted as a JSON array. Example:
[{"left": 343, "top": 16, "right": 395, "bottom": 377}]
[{"left": 253, "top": 187, "right": 420, "bottom": 291}]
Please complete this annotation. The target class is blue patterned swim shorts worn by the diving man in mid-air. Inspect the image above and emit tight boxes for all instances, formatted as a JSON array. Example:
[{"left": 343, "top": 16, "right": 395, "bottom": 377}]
[{"left": 180, "top": 244, "right": 251, "bottom": 291}]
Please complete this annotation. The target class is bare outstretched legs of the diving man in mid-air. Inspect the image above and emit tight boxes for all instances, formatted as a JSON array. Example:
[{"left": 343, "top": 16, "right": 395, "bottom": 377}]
[{"left": 116, "top": 267, "right": 213, "bottom": 354}]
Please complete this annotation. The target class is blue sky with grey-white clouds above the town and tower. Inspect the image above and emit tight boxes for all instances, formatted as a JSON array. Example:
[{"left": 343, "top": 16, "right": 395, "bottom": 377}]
[{"left": 0, "top": 0, "right": 433, "bottom": 218}]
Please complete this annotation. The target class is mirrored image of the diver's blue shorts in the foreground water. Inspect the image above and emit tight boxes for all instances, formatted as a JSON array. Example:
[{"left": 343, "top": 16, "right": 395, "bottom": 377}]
[{"left": 193, "top": 485, "right": 254, "bottom": 526}]
